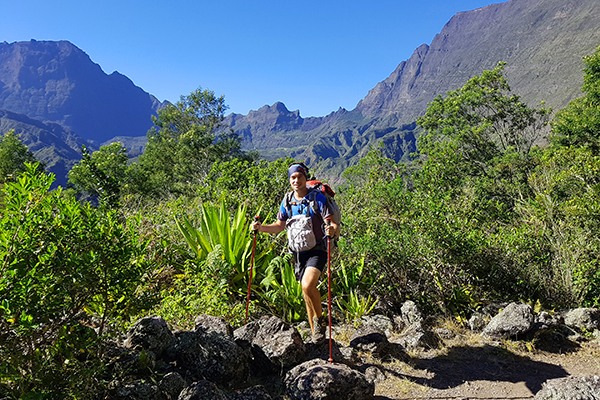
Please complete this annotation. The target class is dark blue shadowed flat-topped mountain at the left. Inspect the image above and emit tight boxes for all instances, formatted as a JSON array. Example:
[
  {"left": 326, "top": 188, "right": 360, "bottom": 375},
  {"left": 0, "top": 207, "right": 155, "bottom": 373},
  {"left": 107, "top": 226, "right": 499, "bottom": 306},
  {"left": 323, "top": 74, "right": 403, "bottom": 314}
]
[{"left": 0, "top": 40, "right": 161, "bottom": 143}]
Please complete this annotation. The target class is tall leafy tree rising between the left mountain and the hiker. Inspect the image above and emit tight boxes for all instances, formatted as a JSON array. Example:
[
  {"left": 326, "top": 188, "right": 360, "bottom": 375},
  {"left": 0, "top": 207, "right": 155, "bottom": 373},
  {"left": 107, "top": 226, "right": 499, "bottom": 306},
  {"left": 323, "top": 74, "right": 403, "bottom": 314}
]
[{"left": 134, "top": 88, "right": 244, "bottom": 197}]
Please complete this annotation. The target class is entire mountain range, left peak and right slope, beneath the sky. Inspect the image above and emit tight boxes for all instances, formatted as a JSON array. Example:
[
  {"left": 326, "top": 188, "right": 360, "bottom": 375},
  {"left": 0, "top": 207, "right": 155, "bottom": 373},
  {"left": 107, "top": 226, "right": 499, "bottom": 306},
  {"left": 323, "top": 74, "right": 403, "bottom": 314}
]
[{"left": 0, "top": 0, "right": 600, "bottom": 185}]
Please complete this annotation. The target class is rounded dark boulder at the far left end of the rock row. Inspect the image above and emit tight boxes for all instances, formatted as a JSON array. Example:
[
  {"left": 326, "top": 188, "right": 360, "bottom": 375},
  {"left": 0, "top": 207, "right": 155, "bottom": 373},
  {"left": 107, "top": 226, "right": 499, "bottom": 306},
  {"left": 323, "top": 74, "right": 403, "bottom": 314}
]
[{"left": 125, "top": 315, "right": 175, "bottom": 357}]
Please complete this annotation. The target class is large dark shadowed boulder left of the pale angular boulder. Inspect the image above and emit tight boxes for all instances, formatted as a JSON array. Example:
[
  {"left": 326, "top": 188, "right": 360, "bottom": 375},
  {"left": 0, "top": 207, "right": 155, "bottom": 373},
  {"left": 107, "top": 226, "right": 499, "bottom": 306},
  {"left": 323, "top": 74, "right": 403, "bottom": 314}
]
[{"left": 175, "top": 331, "right": 249, "bottom": 386}]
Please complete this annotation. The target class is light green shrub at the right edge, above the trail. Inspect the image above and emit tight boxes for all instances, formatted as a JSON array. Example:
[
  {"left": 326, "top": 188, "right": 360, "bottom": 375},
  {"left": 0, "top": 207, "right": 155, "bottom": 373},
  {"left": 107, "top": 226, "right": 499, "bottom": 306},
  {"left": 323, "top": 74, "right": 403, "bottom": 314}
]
[{"left": 519, "top": 147, "right": 600, "bottom": 305}]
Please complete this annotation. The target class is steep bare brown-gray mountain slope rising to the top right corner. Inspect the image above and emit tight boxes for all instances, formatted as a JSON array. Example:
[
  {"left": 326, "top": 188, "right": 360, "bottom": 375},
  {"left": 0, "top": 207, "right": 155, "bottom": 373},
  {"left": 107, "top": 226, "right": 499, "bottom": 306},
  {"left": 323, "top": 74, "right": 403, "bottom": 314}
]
[{"left": 356, "top": 0, "right": 600, "bottom": 123}]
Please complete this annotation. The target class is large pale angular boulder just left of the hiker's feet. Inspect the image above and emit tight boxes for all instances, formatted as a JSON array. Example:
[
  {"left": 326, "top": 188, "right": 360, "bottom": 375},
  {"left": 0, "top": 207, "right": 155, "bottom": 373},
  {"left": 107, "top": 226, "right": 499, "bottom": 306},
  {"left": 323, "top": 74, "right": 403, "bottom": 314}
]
[{"left": 252, "top": 316, "right": 306, "bottom": 369}]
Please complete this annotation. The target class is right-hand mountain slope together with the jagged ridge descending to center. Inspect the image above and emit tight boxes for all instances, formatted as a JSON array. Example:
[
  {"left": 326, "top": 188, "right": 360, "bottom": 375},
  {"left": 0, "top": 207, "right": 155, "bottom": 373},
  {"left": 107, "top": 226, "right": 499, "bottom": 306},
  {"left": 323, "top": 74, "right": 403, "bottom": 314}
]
[{"left": 229, "top": 0, "right": 600, "bottom": 166}]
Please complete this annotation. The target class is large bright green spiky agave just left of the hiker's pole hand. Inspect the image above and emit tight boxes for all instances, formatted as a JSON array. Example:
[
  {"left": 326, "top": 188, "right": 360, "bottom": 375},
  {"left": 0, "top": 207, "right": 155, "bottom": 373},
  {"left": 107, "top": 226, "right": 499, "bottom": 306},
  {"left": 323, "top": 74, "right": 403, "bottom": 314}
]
[{"left": 175, "top": 201, "right": 273, "bottom": 289}]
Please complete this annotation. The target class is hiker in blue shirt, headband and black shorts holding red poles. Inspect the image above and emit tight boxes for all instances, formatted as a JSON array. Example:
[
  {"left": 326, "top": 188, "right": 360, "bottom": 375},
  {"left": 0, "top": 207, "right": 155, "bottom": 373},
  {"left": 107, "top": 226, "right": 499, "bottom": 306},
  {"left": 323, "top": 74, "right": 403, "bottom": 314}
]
[{"left": 252, "top": 163, "right": 338, "bottom": 343}]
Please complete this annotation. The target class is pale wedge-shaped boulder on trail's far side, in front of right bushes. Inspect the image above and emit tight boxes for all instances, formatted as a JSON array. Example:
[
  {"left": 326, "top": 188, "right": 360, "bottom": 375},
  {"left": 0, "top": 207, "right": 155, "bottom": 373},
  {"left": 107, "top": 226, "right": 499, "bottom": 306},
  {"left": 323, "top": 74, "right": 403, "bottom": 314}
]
[{"left": 481, "top": 303, "right": 534, "bottom": 339}]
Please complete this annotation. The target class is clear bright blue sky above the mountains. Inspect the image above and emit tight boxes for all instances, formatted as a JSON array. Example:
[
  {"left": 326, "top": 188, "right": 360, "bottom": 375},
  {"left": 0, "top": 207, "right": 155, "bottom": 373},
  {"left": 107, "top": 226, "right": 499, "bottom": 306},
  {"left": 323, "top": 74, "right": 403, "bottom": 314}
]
[{"left": 0, "top": 0, "right": 504, "bottom": 117}]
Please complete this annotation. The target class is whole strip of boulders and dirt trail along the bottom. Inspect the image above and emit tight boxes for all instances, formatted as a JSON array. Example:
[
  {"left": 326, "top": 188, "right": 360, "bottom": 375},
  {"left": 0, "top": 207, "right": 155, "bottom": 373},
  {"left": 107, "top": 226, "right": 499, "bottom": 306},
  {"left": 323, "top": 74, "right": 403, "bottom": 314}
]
[{"left": 113, "top": 301, "right": 600, "bottom": 400}]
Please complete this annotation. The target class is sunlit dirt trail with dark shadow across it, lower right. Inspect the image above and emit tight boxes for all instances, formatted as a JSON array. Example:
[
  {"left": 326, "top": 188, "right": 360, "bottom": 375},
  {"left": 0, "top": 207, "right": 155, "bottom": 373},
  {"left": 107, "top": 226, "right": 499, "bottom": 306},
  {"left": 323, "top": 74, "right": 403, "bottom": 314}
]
[{"left": 350, "top": 324, "right": 600, "bottom": 400}]
